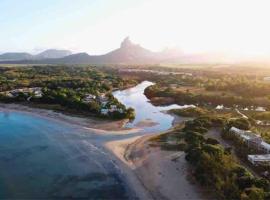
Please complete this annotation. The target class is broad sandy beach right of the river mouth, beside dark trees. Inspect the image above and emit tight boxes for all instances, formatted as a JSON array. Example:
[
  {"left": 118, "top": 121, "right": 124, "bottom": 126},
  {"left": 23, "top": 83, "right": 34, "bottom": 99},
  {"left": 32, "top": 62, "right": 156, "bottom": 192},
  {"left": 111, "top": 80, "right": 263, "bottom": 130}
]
[{"left": 107, "top": 135, "right": 205, "bottom": 200}]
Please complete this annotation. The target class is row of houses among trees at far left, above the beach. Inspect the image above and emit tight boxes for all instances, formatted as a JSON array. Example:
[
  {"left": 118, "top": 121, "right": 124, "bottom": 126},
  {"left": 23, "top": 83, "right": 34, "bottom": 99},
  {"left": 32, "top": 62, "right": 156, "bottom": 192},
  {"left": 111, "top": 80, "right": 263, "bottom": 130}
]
[{"left": 5, "top": 87, "right": 43, "bottom": 98}]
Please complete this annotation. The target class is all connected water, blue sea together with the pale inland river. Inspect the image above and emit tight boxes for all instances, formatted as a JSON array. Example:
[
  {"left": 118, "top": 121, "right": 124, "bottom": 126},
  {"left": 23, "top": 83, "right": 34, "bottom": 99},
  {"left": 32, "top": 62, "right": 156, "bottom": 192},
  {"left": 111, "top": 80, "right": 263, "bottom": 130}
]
[{"left": 0, "top": 81, "right": 190, "bottom": 199}]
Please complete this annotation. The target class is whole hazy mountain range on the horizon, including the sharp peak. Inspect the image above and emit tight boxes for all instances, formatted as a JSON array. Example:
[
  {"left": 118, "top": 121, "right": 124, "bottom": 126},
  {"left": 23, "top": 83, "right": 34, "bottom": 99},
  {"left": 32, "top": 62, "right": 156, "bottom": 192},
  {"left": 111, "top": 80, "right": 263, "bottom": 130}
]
[{"left": 0, "top": 37, "right": 224, "bottom": 64}]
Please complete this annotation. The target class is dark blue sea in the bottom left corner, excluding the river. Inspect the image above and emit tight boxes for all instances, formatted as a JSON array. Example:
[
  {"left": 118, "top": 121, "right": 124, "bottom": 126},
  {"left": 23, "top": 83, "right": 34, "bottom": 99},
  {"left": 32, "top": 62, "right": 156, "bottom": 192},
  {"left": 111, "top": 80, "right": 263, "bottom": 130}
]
[{"left": 0, "top": 112, "right": 127, "bottom": 199}]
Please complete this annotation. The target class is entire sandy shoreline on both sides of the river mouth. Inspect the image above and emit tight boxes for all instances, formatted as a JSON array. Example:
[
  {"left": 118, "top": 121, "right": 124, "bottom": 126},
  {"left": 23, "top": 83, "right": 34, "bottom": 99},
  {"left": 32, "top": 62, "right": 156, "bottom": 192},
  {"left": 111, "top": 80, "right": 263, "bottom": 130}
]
[{"left": 0, "top": 103, "right": 205, "bottom": 200}]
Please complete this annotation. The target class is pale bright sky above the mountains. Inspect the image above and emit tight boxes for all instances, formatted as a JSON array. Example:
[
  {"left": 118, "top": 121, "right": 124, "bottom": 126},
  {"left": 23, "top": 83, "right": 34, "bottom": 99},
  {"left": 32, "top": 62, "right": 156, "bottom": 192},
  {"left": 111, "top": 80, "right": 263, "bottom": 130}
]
[{"left": 0, "top": 0, "right": 270, "bottom": 57}]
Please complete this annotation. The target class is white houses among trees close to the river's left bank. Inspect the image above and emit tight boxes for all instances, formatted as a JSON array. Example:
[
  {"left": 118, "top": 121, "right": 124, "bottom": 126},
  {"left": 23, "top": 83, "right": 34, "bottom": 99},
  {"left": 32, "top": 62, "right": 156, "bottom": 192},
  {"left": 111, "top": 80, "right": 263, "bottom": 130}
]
[{"left": 83, "top": 93, "right": 124, "bottom": 115}]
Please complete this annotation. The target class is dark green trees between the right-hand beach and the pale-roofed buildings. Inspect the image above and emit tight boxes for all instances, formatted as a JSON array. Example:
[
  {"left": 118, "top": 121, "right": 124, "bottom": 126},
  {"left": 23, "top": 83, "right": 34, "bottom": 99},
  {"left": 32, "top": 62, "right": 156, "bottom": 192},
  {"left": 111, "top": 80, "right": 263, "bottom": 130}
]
[{"left": 182, "top": 117, "right": 270, "bottom": 200}]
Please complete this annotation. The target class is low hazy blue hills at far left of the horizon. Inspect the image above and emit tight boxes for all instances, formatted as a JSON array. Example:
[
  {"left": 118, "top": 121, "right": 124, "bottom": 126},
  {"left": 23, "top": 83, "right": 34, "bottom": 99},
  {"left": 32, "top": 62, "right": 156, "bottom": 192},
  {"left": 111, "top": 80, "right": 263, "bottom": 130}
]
[{"left": 0, "top": 49, "right": 72, "bottom": 61}]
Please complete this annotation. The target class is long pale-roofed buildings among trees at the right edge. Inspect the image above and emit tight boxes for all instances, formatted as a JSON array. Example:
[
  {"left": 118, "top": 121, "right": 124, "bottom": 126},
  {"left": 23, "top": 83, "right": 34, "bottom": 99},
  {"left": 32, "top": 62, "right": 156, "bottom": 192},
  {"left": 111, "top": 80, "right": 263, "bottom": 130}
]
[{"left": 229, "top": 127, "right": 270, "bottom": 165}]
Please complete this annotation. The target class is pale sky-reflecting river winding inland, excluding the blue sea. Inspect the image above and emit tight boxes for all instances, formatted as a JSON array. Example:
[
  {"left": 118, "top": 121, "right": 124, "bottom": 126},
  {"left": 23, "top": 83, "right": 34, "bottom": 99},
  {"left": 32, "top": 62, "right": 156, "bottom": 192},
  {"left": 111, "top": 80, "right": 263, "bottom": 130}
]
[{"left": 113, "top": 81, "right": 192, "bottom": 133}]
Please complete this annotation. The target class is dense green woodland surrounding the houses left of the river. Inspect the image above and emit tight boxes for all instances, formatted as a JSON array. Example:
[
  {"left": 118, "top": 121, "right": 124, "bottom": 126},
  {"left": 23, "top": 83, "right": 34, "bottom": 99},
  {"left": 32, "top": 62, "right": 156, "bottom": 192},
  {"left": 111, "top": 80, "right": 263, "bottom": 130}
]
[{"left": 0, "top": 66, "right": 134, "bottom": 118}]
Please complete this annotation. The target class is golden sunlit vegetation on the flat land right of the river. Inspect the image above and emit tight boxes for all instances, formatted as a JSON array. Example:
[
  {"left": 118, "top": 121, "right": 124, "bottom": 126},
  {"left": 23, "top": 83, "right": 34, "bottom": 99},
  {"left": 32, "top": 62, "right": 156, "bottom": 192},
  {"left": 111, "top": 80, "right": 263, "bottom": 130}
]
[{"left": 131, "top": 69, "right": 270, "bottom": 108}]
